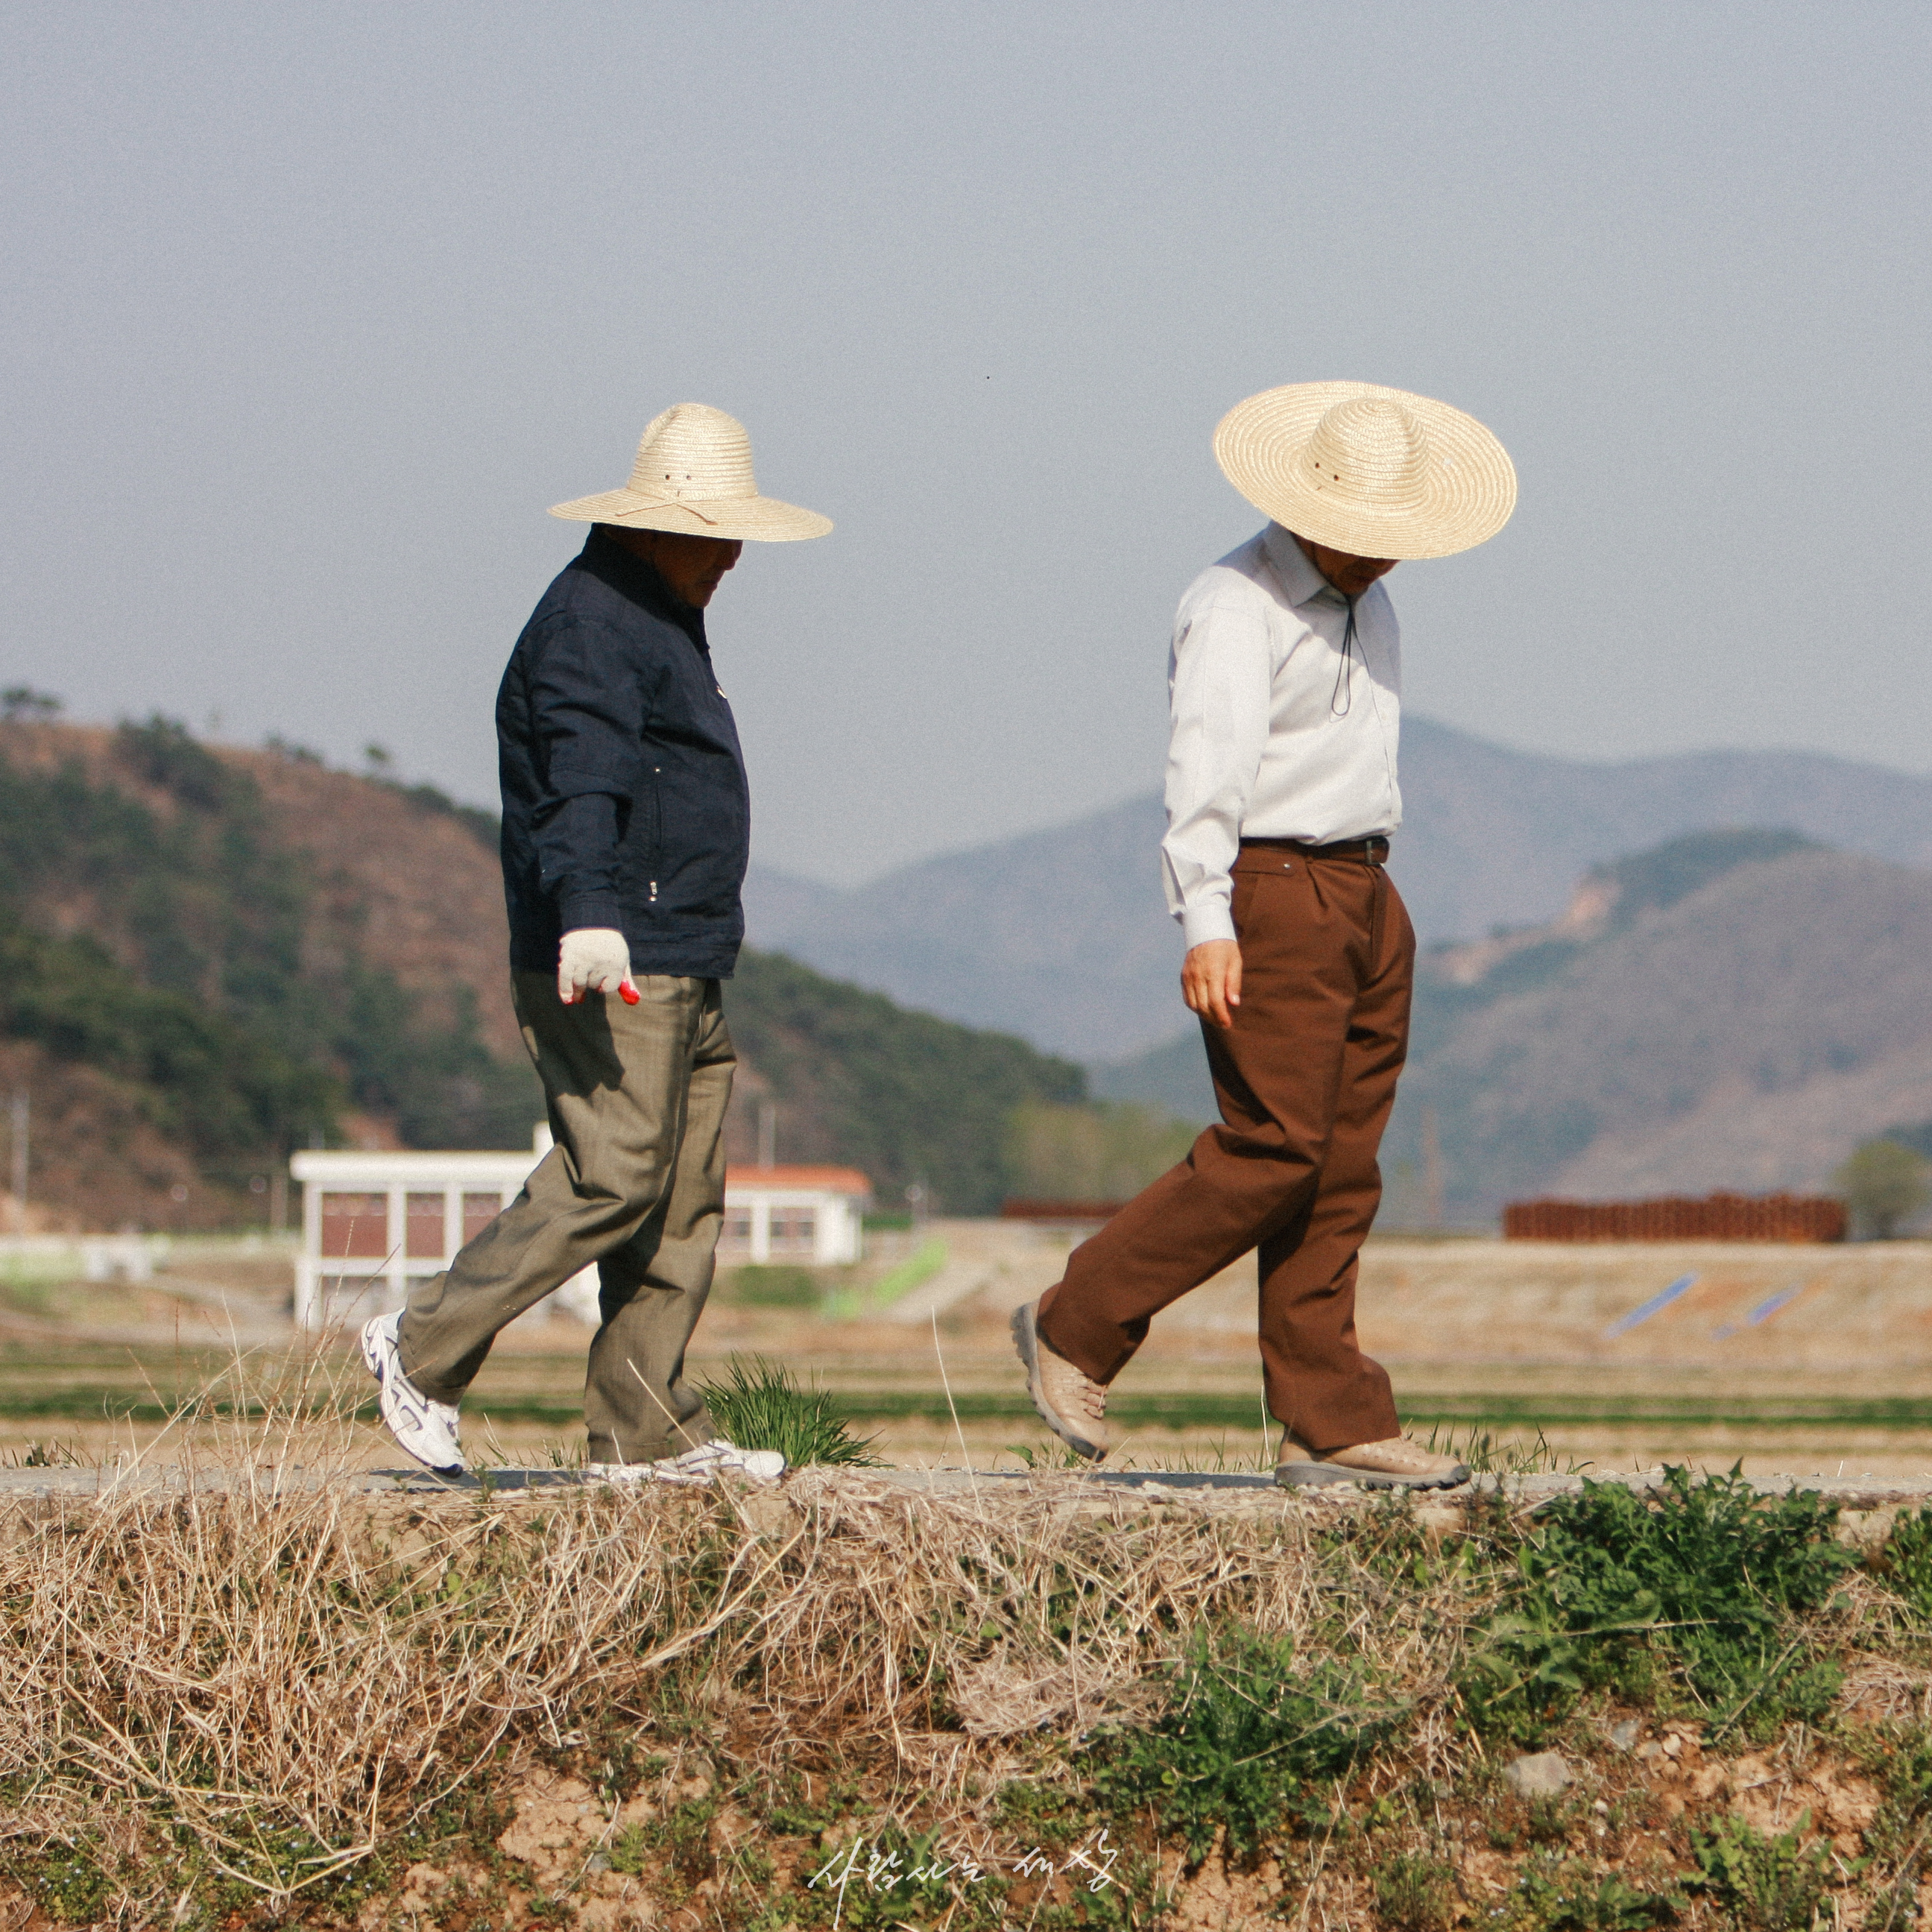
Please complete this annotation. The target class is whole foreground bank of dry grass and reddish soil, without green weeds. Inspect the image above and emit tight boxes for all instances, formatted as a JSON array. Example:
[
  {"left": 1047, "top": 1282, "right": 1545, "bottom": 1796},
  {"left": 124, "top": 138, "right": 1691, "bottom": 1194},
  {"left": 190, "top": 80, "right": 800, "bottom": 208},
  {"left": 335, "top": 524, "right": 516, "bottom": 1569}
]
[{"left": 11, "top": 1391, "right": 1926, "bottom": 1932}]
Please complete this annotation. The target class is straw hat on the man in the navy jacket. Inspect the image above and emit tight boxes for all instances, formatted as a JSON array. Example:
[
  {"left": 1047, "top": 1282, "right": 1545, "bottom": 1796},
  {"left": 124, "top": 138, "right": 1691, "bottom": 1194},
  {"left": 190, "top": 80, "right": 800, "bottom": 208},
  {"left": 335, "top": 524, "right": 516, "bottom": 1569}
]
[{"left": 551, "top": 402, "right": 833, "bottom": 543}]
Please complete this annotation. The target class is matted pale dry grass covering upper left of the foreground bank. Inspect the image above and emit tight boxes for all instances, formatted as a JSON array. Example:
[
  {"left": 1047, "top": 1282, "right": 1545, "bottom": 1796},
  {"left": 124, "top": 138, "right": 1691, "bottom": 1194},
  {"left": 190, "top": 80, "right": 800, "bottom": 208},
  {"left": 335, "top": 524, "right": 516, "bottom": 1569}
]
[{"left": 0, "top": 1375, "right": 1482, "bottom": 1919}]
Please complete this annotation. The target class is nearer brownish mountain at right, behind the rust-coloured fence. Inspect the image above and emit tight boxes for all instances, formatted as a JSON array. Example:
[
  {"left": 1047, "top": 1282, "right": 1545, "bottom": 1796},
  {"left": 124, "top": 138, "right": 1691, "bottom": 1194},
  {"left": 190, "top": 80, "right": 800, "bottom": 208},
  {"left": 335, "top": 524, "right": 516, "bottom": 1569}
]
[{"left": 1383, "top": 841, "right": 1932, "bottom": 1221}]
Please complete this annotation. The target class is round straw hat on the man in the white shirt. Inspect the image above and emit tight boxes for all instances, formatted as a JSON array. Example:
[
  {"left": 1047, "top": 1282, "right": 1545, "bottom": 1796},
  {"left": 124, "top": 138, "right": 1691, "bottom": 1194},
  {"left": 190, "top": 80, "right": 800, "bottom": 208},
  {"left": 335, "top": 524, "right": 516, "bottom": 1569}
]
[{"left": 1213, "top": 382, "right": 1517, "bottom": 561}]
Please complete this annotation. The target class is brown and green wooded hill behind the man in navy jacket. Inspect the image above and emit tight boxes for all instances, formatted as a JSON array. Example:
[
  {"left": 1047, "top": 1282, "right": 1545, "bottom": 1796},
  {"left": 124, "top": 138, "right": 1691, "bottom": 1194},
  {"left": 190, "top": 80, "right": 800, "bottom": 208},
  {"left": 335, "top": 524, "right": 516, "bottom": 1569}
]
[{"left": 0, "top": 719, "right": 1084, "bottom": 1227}]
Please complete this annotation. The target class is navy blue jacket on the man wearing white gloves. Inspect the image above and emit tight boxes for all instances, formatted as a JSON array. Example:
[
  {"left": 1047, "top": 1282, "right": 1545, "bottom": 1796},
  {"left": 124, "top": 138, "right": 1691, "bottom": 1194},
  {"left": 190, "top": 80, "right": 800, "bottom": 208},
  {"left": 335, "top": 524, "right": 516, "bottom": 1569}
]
[{"left": 496, "top": 529, "right": 751, "bottom": 979}]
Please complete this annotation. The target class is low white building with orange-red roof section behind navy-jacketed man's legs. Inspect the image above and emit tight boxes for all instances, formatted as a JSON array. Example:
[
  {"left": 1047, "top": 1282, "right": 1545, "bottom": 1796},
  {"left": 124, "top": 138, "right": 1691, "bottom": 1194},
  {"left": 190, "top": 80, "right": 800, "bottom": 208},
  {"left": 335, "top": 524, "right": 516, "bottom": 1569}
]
[{"left": 288, "top": 1125, "right": 871, "bottom": 1329}]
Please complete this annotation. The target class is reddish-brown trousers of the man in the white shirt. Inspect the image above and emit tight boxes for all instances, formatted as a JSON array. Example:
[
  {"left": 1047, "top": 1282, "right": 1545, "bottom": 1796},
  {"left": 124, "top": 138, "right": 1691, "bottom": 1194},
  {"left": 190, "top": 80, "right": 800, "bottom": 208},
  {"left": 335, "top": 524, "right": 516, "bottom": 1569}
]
[{"left": 1039, "top": 845, "right": 1416, "bottom": 1453}]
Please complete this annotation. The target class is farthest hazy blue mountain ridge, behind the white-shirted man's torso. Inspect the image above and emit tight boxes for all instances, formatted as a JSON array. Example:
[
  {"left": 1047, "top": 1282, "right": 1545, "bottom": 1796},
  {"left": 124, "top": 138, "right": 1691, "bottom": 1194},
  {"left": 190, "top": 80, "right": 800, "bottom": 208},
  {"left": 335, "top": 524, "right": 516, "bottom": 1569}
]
[{"left": 748, "top": 717, "right": 1932, "bottom": 1078}]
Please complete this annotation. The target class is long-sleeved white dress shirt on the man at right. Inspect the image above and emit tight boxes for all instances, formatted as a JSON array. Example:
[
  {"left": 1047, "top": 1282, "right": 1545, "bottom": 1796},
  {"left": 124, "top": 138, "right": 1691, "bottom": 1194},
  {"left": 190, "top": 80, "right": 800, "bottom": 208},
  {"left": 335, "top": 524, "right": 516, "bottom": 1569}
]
[{"left": 1161, "top": 523, "right": 1403, "bottom": 947}]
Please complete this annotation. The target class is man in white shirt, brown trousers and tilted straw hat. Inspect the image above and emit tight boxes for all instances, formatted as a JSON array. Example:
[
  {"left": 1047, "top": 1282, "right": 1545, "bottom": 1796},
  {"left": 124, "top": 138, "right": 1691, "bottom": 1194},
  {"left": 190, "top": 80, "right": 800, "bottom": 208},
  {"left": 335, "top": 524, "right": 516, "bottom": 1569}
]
[{"left": 1014, "top": 382, "right": 1517, "bottom": 1488}]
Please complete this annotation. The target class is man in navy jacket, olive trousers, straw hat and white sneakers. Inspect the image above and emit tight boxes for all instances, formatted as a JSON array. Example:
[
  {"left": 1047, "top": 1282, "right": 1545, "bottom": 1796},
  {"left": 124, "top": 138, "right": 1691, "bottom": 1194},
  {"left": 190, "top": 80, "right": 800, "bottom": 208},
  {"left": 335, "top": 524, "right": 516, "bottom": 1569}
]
[{"left": 363, "top": 402, "right": 831, "bottom": 1482}]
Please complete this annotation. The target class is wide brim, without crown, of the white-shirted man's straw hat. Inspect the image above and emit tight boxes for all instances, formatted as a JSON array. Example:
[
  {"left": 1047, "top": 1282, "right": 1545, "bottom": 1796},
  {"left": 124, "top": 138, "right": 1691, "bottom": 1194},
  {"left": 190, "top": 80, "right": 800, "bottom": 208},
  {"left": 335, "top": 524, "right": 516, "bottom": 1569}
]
[{"left": 1213, "top": 382, "right": 1517, "bottom": 562}]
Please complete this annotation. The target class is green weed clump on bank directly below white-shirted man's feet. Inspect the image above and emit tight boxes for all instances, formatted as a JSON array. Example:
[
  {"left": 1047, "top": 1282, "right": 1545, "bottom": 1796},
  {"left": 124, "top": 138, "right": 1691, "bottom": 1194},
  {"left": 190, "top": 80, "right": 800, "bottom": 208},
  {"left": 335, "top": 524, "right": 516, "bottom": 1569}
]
[{"left": 1093, "top": 1623, "right": 1399, "bottom": 1863}]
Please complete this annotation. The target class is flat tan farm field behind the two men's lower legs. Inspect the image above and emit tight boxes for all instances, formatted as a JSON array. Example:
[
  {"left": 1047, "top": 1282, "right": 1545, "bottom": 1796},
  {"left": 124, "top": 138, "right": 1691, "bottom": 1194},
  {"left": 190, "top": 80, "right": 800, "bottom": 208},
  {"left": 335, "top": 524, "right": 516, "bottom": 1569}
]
[{"left": 0, "top": 1221, "right": 1932, "bottom": 1476}]
